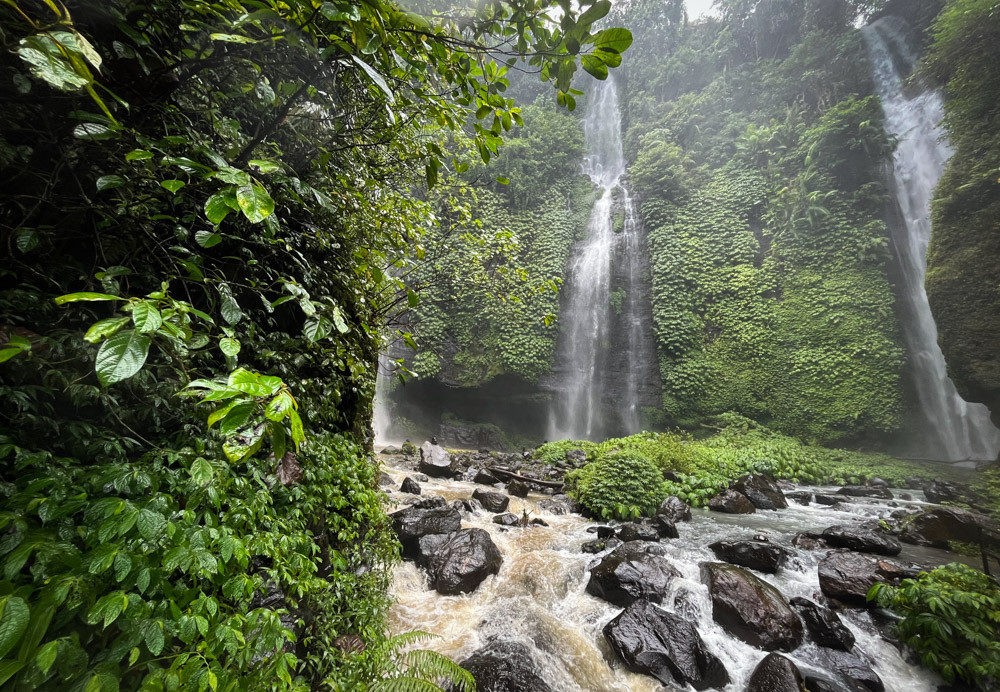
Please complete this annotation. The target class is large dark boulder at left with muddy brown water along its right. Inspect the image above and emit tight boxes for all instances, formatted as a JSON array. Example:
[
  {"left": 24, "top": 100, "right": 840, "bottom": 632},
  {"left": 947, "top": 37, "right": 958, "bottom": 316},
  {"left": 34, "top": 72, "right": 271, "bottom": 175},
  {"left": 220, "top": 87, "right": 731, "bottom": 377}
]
[{"left": 420, "top": 529, "right": 503, "bottom": 596}]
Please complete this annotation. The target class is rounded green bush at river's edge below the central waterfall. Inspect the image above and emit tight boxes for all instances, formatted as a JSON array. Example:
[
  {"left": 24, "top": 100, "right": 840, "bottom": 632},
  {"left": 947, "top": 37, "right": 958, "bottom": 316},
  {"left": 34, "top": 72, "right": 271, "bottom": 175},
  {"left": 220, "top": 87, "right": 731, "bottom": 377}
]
[{"left": 566, "top": 451, "right": 667, "bottom": 519}]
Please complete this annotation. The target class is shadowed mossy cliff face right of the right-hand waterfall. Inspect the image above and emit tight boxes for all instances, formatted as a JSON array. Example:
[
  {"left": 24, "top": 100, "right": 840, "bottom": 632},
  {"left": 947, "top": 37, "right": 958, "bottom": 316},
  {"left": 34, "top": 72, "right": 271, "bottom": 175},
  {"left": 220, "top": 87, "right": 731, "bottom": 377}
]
[{"left": 925, "top": 0, "right": 1000, "bottom": 422}]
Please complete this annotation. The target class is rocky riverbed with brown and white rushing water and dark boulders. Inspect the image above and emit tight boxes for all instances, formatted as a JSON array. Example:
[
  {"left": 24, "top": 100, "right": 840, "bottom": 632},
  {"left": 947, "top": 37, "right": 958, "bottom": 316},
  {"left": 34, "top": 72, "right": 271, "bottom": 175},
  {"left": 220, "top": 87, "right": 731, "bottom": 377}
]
[{"left": 381, "top": 443, "right": 985, "bottom": 692}]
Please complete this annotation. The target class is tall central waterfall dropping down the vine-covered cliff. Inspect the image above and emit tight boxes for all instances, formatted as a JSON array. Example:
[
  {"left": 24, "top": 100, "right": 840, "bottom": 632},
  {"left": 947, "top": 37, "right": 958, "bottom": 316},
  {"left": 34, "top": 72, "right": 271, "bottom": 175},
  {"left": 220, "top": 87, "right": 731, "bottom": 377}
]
[{"left": 549, "top": 77, "right": 654, "bottom": 439}]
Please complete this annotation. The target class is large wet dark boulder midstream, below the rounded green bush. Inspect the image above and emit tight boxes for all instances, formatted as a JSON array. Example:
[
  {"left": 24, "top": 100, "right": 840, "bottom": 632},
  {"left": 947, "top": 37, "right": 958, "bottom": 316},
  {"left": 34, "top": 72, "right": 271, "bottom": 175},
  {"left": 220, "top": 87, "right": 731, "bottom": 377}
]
[{"left": 587, "top": 542, "right": 681, "bottom": 607}]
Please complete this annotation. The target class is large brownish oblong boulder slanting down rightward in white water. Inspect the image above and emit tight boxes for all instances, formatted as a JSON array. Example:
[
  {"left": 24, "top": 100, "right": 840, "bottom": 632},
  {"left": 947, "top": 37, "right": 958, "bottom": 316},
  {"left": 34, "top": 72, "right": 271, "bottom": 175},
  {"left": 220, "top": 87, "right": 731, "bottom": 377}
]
[{"left": 701, "top": 562, "right": 802, "bottom": 651}]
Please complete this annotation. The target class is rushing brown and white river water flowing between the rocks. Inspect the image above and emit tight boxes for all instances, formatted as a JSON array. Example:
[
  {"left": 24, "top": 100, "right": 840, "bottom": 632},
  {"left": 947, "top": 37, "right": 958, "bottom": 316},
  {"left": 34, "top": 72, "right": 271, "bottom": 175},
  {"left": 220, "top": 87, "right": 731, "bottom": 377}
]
[{"left": 387, "top": 460, "right": 955, "bottom": 692}]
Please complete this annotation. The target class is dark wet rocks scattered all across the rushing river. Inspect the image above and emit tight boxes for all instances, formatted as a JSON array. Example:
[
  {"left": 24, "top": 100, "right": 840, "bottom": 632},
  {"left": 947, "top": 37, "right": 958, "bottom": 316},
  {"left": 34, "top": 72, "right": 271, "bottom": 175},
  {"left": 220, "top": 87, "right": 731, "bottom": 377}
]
[{"left": 378, "top": 443, "right": 989, "bottom": 692}]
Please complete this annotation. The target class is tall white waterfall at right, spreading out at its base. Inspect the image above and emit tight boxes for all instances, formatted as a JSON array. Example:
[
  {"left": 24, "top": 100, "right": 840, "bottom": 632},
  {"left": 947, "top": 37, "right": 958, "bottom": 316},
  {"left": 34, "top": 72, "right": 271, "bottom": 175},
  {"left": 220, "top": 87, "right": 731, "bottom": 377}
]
[{"left": 864, "top": 17, "right": 1000, "bottom": 461}]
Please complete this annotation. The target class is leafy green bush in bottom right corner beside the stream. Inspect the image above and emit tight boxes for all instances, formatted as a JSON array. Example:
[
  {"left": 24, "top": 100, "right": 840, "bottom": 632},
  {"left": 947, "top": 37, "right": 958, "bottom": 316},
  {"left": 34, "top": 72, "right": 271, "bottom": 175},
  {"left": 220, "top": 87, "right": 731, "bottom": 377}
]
[{"left": 868, "top": 563, "right": 1000, "bottom": 690}]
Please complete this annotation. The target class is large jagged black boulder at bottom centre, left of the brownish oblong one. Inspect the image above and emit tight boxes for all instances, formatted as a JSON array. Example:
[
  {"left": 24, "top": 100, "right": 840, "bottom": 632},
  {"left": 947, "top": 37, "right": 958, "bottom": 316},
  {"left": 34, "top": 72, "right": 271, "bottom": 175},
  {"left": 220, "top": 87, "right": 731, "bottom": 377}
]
[{"left": 604, "top": 600, "right": 729, "bottom": 690}]
